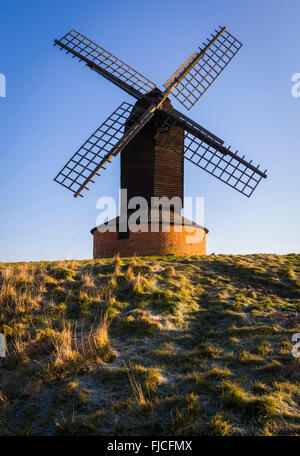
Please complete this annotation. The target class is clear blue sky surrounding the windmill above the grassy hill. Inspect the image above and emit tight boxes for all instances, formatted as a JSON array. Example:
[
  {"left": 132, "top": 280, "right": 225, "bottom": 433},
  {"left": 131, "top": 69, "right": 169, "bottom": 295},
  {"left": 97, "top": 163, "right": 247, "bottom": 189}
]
[{"left": 0, "top": 0, "right": 300, "bottom": 261}]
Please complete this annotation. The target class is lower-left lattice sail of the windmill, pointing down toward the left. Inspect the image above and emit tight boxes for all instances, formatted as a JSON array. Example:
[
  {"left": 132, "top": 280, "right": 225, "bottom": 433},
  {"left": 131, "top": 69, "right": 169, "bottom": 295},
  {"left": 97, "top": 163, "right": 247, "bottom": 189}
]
[{"left": 54, "top": 102, "right": 144, "bottom": 196}]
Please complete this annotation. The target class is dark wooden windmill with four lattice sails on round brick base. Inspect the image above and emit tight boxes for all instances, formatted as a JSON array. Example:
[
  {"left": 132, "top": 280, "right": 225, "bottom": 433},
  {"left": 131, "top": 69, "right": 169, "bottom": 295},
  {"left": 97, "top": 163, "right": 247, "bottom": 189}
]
[{"left": 54, "top": 27, "right": 267, "bottom": 257}]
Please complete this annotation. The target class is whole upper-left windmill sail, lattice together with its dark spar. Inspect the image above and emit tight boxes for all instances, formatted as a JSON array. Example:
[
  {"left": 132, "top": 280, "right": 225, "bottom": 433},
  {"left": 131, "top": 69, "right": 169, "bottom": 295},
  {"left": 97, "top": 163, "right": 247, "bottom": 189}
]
[{"left": 54, "top": 30, "right": 156, "bottom": 98}]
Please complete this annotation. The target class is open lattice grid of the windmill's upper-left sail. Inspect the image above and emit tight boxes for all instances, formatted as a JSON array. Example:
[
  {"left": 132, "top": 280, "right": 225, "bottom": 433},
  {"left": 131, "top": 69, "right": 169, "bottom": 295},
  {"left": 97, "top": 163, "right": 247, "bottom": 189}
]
[{"left": 57, "top": 30, "right": 156, "bottom": 94}]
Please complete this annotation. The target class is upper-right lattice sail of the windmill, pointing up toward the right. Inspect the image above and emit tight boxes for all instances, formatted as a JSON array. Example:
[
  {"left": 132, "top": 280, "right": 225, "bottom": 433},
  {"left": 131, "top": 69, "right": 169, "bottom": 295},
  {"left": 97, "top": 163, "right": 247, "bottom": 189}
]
[{"left": 172, "top": 27, "right": 242, "bottom": 110}]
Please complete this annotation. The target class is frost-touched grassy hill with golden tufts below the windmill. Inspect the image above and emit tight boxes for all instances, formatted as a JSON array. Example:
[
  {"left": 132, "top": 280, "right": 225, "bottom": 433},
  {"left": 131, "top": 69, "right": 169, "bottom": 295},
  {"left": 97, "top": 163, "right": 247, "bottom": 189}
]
[{"left": 0, "top": 254, "right": 300, "bottom": 435}]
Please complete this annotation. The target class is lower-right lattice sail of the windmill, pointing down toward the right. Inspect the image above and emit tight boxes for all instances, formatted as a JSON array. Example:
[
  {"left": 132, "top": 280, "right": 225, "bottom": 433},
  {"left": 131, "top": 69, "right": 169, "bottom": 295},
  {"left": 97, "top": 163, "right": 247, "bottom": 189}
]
[{"left": 156, "top": 112, "right": 267, "bottom": 197}]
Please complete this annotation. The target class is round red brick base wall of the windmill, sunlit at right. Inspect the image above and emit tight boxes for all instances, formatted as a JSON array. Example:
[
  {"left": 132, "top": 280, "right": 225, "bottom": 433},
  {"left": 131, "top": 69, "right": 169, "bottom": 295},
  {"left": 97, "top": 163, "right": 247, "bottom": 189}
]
[{"left": 93, "top": 225, "right": 206, "bottom": 258}]
